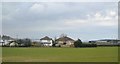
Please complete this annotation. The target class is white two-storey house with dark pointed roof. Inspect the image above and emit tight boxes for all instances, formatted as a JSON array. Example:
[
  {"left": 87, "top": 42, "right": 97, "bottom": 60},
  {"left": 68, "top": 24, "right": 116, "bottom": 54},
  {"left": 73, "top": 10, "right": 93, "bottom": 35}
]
[{"left": 40, "top": 36, "right": 53, "bottom": 46}]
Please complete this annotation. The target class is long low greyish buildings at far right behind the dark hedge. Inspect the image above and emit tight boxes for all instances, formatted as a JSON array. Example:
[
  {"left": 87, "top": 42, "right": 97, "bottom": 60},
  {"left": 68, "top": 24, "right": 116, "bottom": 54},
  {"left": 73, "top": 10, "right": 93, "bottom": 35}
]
[{"left": 89, "top": 39, "right": 120, "bottom": 45}]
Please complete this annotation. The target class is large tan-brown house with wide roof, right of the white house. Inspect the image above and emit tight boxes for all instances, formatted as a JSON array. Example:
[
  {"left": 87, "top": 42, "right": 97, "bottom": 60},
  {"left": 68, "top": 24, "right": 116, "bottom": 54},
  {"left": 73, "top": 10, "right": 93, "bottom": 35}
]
[{"left": 55, "top": 36, "right": 75, "bottom": 47}]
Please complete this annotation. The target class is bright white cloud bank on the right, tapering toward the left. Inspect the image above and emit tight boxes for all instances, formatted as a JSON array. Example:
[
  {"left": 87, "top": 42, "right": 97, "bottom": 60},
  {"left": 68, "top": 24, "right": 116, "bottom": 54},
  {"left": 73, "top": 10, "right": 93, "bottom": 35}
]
[{"left": 63, "top": 11, "right": 118, "bottom": 28}]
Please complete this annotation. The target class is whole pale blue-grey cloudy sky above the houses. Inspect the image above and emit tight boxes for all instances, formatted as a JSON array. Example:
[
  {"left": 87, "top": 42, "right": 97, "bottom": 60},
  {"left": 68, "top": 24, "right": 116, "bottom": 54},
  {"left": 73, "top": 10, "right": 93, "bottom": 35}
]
[{"left": 2, "top": 2, "right": 118, "bottom": 41}]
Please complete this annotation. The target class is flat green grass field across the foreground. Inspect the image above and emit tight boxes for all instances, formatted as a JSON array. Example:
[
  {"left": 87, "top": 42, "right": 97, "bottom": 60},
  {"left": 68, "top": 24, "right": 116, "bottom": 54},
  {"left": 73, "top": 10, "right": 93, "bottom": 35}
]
[{"left": 2, "top": 47, "right": 118, "bottom": 62}]
